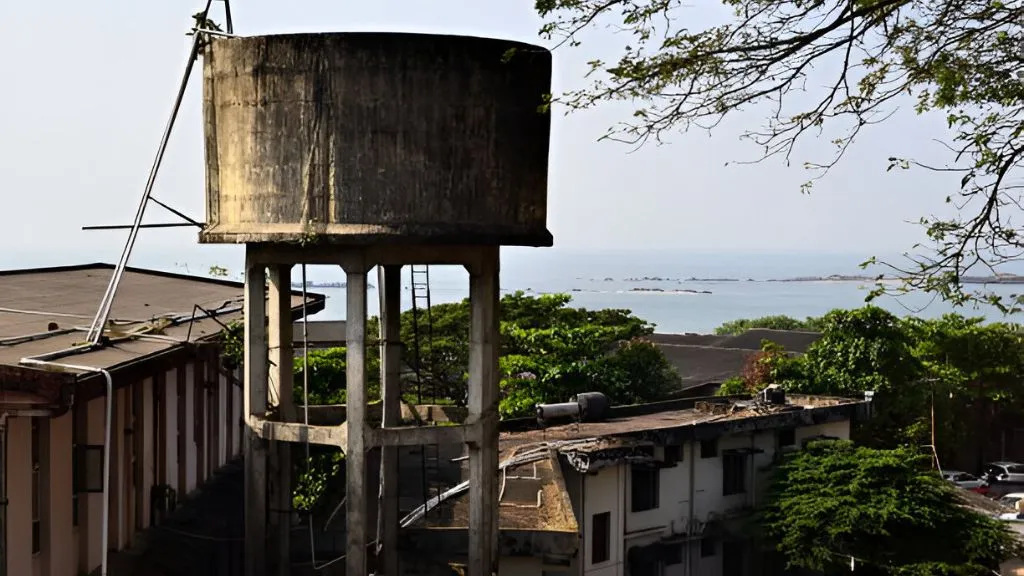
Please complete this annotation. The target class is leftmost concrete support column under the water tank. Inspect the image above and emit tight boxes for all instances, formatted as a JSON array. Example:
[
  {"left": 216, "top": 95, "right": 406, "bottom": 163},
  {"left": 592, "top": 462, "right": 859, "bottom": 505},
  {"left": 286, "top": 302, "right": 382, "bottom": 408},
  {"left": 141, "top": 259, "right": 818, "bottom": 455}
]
[{"left": 243, "top": 253, "right": 268, "bottom": 576}]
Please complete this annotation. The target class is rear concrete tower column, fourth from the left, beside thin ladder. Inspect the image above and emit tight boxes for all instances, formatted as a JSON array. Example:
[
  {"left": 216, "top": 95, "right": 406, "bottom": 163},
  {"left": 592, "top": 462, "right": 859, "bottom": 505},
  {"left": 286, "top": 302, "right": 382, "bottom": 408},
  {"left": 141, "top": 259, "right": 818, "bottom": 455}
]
[{"left": 377, "top": 265, "right": 401, "bottom": 576}]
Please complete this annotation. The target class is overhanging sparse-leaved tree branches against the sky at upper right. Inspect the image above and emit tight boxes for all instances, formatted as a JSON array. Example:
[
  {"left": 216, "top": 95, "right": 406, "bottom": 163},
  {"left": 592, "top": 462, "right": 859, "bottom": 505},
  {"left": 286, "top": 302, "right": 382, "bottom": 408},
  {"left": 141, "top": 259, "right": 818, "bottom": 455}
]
[{"left": 536, "top": 0, "right": 1024, "bottom": 310}]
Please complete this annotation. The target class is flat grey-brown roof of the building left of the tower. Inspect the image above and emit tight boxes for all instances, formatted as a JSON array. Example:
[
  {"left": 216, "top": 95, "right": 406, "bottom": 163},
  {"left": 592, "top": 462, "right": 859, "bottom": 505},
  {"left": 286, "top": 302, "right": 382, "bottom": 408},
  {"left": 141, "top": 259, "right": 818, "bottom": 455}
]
[{"left": 0, "top": 263, "right": 324, "bottom": 401}]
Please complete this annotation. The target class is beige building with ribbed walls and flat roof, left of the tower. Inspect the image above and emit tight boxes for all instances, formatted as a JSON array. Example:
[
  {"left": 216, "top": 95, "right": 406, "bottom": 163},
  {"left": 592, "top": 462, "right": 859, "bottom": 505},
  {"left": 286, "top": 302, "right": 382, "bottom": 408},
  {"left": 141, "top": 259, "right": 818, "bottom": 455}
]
[{"left": 0, "top": 264, "right": 324, "bottom": 576}]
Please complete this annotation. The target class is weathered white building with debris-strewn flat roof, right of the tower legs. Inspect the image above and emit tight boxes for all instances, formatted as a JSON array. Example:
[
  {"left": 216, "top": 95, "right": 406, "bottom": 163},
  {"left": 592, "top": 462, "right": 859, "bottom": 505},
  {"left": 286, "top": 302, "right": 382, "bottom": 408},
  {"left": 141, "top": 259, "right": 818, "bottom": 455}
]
[{"left": 404, "top": 387, "right": 869, "bottom": 576}]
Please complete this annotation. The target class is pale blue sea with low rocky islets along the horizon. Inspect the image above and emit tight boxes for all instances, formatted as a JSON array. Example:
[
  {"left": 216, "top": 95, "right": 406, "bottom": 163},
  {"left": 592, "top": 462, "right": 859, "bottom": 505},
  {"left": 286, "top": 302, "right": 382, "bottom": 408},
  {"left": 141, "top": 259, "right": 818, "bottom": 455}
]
[{"left": 280, "top": 249, "right": 1024, "bottom": 333}]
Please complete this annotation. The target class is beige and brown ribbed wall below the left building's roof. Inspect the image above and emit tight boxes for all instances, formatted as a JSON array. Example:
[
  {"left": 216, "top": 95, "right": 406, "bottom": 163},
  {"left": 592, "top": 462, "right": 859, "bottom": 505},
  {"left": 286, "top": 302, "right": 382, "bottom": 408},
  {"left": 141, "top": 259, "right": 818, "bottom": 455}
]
[{"left": 6, "top": 354, "right": 242, "bottom": 576}]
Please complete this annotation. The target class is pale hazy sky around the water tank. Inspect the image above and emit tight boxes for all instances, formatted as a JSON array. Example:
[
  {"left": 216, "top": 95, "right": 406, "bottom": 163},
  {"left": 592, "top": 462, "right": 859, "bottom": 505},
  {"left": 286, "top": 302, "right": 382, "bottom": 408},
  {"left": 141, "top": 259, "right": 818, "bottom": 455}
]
[{"left": 0, "top": 0, "right": 957, "bottom": 265}]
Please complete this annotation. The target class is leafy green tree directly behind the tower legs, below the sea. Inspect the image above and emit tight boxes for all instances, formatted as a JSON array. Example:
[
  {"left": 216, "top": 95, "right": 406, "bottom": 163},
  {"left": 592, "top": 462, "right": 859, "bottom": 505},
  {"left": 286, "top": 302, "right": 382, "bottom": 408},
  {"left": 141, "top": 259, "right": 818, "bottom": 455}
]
[{"left": 368, "top": 292, "right": 678, "bottom": 417}]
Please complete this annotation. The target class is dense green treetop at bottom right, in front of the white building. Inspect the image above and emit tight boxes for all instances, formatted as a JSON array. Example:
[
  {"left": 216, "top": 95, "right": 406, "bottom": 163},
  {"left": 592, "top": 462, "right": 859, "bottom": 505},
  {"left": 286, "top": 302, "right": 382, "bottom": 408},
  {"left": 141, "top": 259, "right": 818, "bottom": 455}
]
[{"left": 760, "top": 441, "right": 1021, "bottom": 576}]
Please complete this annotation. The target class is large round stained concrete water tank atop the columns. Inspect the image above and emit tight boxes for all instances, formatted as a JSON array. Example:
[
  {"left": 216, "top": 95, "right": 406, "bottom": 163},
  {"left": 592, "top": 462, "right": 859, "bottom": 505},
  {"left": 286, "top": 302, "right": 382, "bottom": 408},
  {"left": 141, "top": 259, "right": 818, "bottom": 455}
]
[{"left": 200, "top": 33, "right": 552, "bottom": 246}]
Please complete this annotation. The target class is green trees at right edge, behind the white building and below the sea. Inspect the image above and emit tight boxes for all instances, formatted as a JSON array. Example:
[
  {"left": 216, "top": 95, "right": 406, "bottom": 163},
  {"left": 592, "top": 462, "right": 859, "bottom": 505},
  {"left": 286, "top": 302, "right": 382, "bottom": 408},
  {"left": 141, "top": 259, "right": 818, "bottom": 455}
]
[{"left": 719, "top": 306, "right": 1024, "bottom": 459}]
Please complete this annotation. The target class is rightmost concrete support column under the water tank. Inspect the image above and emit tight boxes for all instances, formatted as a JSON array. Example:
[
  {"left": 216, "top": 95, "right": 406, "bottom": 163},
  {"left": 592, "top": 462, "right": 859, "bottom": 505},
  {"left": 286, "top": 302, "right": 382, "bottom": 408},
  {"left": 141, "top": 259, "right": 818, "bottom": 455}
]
[{"left": 467, "top": 246, "right": 499, "bottom": 576}]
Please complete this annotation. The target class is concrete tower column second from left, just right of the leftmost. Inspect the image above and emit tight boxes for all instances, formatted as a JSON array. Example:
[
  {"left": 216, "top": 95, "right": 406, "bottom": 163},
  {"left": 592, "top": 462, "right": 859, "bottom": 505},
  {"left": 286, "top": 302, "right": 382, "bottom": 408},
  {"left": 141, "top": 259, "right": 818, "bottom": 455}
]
[{"left": 267, "top": 264, "right": 295, "bottom": 576}]
